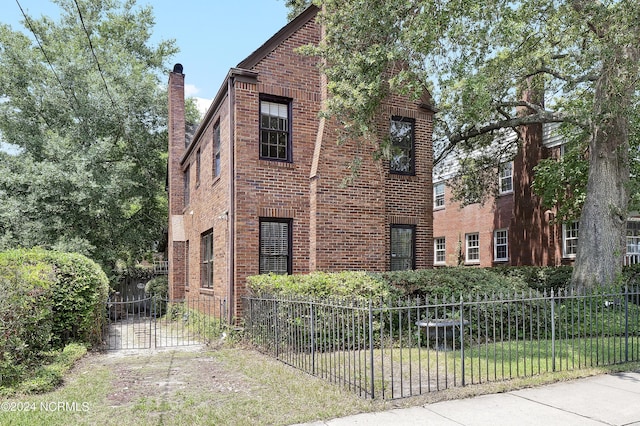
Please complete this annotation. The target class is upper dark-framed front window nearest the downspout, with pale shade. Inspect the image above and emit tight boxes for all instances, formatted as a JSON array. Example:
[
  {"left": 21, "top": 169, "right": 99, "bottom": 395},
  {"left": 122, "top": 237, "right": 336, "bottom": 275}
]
[{"left": 260, "top": 97, "right": 292, "bottom": 161}]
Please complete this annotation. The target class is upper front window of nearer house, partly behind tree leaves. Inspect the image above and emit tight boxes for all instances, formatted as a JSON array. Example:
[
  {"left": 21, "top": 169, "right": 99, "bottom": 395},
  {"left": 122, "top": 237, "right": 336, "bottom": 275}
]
[{"left": 389, "top": 117, "right": 416, "bottom": 175}]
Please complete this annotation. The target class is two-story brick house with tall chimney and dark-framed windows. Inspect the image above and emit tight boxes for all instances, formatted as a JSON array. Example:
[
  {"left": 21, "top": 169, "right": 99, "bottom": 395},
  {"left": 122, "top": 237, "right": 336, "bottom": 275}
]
[{"left": 168, "top": 6, "right": 433, "bottom": 320}]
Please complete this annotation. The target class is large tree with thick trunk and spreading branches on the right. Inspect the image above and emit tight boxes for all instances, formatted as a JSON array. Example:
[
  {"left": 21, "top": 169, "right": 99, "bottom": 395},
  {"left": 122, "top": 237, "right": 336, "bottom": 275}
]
[{"left": 298, "top": 0, "right": 640, "bottom": 287}]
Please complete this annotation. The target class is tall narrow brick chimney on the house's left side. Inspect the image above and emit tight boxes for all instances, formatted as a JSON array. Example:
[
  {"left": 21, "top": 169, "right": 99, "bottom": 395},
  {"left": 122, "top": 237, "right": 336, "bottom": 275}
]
[{"left": 167, "top": 64, "right": 188, "bottom": 299}]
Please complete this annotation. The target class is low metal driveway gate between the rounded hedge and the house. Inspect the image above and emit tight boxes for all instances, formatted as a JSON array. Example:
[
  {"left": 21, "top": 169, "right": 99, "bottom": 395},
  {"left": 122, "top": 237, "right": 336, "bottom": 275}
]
[{"left": 103, "top": 296, "right": 219, "bottom": 350}]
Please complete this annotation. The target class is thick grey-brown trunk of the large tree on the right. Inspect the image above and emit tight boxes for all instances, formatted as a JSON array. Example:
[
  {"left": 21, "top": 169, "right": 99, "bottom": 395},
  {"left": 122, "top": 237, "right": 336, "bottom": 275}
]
[{"left": 572, "top": 48, "right": 638, "bottom": 288}]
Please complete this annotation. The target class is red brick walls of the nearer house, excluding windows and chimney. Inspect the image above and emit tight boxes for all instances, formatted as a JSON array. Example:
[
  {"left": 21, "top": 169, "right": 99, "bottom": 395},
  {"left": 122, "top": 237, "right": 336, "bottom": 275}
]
[{"left": 172, "top": 12, "right": 433, "bottom": 316}]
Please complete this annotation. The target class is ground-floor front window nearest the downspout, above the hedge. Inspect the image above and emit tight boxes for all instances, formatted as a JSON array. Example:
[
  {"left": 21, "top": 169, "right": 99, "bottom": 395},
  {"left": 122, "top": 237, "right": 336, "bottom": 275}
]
[{"left": 260, "top": 219, "right": 292, "bottom": 274}]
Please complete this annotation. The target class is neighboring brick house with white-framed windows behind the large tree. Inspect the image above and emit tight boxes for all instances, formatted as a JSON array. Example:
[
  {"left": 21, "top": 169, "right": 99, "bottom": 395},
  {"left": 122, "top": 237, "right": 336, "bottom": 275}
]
[{"left": 433, "top": 119, "right": 640, "bottom": 267}]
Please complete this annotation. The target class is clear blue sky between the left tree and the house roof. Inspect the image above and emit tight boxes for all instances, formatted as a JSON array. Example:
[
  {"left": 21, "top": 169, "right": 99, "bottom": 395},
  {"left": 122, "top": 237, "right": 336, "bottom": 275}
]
[{"left": 0, "top": 0, "right": 287, "bottom": 103}]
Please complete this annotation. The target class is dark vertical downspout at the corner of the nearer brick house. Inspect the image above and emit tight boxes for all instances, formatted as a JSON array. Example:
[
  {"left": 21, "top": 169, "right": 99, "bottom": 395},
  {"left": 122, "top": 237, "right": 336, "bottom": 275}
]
[{"left": 227, "top": 73, "right": 236, "bottom": 325}]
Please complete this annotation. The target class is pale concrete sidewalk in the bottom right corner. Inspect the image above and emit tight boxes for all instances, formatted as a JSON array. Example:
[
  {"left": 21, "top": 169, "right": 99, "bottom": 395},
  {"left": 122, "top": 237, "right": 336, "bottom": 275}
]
[{"left": 300, "top": 372, "right": 640, "bottom": 426}]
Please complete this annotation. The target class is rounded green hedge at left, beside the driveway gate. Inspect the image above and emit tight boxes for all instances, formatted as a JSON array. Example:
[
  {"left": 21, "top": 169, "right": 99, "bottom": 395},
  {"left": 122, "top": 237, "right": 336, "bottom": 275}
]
[{"left": 0, "top": 249, "right": 109, "bottom": 379}]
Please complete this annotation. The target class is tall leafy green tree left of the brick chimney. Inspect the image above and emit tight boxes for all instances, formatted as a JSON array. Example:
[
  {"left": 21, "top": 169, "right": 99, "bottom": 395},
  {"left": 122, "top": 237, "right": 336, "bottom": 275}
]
[{"left": 0, "top": 0, "right": 176, "bottom": 267}]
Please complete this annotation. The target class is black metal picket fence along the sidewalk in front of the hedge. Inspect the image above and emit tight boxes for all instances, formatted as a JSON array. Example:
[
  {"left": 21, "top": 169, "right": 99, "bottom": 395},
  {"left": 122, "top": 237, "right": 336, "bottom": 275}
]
[{"left": 244, "top": 288, "right": 640, "bottom": 399}]
